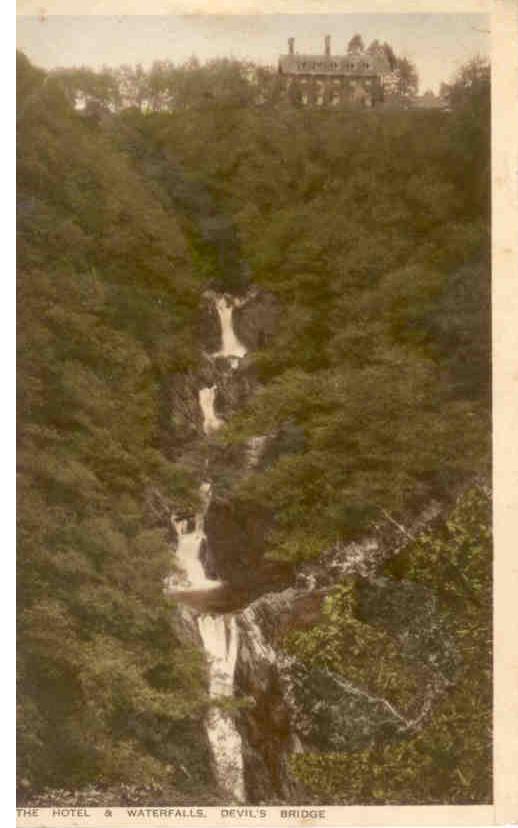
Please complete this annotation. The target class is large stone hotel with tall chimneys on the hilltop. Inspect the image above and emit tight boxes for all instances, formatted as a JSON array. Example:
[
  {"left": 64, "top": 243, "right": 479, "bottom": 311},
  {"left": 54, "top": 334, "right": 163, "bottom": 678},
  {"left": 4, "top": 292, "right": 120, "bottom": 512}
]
[{"left": 278, "top": 35, "right": 390, "bottom": 107}]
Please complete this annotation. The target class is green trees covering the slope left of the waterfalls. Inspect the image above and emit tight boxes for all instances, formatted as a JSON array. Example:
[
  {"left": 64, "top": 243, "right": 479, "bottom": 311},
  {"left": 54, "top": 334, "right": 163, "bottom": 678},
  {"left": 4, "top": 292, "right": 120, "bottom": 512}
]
[{"left": 18, "top": 56, "right": 215, "bottom": 788}]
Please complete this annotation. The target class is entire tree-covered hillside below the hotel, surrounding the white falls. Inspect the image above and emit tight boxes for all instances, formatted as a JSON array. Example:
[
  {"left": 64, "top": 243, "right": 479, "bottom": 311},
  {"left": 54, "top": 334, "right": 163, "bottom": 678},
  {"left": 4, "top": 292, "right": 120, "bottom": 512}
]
[{"left": 18, "top": 48, "right": 491, "bottom": 804}]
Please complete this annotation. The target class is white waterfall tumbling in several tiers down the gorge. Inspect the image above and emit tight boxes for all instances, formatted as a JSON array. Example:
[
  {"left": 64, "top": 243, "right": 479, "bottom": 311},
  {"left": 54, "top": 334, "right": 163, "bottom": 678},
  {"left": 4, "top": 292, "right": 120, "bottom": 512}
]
[{"left": 168, "top": 296, "right": 249, "bottom": 802}]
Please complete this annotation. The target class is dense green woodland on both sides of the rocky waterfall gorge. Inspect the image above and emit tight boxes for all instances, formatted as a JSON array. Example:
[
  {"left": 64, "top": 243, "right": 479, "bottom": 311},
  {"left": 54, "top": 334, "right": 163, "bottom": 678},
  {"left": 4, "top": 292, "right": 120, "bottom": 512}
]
[{"left": 18, "top": 43, "right": 491, "bottom": 803}]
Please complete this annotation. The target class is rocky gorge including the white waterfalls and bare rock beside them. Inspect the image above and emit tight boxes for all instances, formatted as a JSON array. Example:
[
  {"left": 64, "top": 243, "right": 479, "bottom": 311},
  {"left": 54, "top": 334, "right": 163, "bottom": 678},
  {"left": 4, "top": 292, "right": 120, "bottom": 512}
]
[{"left": 168, "top": 290, "right": 476, "bottom": 804}]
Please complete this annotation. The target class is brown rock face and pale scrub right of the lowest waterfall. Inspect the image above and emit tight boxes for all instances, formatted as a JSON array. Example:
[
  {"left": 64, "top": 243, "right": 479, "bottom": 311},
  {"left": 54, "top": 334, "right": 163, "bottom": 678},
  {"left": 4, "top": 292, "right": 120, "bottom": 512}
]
[{"left": 231, "top": 510, "right": 459, "bottom": 802}]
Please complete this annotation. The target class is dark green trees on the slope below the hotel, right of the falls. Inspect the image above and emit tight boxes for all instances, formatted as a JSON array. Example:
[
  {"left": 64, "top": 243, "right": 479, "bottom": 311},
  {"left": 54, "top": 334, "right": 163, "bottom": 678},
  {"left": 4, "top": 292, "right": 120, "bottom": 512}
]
[{"left": 100, "top": 51, "right": 490, "bottom": 561}]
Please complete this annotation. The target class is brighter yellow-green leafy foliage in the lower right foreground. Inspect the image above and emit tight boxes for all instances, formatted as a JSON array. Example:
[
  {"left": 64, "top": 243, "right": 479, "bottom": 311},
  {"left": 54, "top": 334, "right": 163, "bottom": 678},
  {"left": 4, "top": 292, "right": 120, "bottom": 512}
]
[{"left": 288, "top": 488, "right": 492, "bottom": 805}]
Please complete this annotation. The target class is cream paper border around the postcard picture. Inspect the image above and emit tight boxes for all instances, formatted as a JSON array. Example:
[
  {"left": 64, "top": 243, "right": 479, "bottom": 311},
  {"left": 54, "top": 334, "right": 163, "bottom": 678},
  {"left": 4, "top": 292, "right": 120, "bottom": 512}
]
[{"left": 12, "top": 0, "right": 518, "bottom": 828}]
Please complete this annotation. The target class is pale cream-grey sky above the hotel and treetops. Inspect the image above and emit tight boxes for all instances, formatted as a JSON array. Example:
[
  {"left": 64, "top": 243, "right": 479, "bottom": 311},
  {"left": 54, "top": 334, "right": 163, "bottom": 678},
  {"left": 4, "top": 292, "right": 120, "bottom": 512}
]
[{"left": 17, "top": 13, "right": 490, "bottom": 92}]
